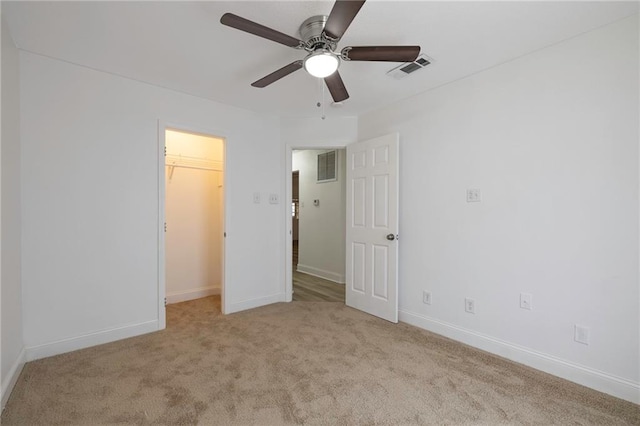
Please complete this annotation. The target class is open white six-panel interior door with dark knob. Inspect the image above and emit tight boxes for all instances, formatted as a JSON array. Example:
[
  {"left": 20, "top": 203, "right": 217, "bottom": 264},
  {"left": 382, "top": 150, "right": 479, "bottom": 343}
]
[{"left": 345, "top": 134, "right": 399, "bottom": 322}]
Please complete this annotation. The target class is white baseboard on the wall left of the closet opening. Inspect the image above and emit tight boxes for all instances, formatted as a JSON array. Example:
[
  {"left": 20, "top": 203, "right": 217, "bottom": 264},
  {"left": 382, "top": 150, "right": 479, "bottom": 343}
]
[{"left": 27, "top": 320, "right": 159, "bottom": 361}]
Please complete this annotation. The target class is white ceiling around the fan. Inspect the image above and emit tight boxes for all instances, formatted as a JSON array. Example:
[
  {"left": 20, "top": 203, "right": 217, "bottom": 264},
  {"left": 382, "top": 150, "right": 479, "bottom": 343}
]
[{"left": 2, "top": 0, "right": 638, "bottom": 116}]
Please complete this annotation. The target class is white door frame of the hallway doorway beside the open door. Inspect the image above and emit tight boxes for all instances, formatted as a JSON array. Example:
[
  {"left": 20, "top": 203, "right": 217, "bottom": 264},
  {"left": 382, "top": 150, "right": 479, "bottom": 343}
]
[{"left": 284, "top": 142, "right": 348, "bottom": 302}]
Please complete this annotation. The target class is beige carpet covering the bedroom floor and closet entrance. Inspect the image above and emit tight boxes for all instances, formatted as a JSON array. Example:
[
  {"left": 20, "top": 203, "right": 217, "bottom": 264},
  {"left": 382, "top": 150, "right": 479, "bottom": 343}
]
[{"left": 2, "top": 298, "right": 640, "bottom": 425}]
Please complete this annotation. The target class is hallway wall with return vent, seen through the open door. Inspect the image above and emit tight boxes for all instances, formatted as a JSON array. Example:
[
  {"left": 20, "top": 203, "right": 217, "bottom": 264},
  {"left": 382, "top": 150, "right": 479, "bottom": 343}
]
[{"left": 292, "top": 149, "right": 346, "bottom": 283}]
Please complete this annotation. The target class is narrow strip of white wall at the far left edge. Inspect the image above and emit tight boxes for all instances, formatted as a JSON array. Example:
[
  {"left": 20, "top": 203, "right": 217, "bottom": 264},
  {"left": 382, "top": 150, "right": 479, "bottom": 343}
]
[{"left": 0, "top": 11, "right": 25, "bottom": 408}]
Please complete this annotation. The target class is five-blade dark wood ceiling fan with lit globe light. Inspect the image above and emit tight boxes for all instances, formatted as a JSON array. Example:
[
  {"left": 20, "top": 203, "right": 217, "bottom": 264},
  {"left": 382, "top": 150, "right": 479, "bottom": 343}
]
[{"left": 220, "top": 0, "right": 420, "bottom": 102}]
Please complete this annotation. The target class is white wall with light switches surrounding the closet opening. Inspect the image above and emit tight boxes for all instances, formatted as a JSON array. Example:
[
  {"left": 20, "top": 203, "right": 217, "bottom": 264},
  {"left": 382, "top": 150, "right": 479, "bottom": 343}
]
[{"left": 20, "top": 52, "right": 286, "bottom": 359}]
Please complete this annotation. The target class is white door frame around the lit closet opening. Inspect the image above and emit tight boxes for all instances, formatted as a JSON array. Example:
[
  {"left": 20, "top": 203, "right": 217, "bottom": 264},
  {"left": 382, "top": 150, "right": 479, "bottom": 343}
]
[{"left": 157, "top": 120, "right": 228, "bottom": 330}]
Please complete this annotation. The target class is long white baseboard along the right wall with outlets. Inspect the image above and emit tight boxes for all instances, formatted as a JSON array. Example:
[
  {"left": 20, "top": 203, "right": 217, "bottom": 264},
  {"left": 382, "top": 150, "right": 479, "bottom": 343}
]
[{"left": 399, "top": 310, "right": 640, "bottom": 404}]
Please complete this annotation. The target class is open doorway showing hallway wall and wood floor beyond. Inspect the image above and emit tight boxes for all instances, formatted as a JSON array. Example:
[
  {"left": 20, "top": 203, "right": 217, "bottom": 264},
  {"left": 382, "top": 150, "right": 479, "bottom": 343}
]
[{"left": 290, "top": 149, "right": 346, "bottom": 303}]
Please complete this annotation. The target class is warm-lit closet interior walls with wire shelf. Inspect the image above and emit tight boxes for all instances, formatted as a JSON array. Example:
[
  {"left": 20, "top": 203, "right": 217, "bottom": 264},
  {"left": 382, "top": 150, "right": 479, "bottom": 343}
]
[{"left": 165, "top": 130, "right": 224, "bottom": 303}]
